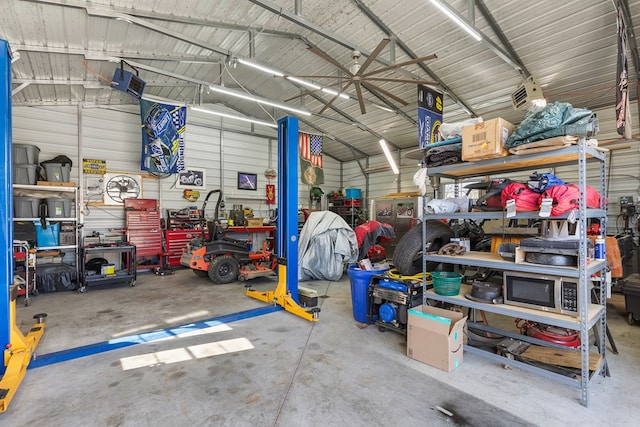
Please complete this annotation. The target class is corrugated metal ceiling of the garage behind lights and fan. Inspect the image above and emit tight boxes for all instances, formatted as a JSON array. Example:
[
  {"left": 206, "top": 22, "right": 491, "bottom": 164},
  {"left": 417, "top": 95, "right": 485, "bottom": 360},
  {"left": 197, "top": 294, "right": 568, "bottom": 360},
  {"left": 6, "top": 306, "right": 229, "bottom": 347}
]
[{"left": 0, "top": 0, "right": 640, "bottom": 161}]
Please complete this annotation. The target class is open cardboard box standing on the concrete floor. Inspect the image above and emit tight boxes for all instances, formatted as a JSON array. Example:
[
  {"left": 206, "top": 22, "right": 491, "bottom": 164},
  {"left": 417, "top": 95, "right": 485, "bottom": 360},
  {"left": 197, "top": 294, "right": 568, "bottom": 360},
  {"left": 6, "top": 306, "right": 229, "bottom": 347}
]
[{"left": 407, "top": 305, "right": 467, "bottom": 372}]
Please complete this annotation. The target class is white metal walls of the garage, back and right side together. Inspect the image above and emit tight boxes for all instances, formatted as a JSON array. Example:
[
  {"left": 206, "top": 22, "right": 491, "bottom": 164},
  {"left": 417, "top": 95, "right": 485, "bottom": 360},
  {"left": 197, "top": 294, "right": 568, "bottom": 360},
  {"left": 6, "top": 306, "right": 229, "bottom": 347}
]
[{"left": 13, "top": 104, "right": 640, "bottom": 239}]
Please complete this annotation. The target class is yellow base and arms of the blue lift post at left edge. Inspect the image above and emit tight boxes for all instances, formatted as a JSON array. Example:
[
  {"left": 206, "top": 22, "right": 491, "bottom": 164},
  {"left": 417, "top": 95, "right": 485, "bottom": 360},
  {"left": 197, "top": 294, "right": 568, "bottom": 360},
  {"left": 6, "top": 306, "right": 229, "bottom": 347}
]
[{"left": 0, "top": 286, "right": 47, "bottom": 413}]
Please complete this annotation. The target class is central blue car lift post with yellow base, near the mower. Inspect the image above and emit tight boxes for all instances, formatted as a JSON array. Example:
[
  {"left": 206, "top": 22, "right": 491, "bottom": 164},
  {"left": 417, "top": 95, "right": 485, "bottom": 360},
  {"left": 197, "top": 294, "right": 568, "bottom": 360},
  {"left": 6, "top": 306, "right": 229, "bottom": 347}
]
[{"left": 246, "top": 117, "right": 320, "bottom": 322}]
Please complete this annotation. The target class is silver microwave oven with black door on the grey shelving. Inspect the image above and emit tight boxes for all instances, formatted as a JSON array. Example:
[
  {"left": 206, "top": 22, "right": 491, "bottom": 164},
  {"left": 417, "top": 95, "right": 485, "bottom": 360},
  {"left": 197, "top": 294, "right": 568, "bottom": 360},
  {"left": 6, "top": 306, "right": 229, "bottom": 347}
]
[{"left": 502, "top": 271, "right": 580, "bottom": 317}]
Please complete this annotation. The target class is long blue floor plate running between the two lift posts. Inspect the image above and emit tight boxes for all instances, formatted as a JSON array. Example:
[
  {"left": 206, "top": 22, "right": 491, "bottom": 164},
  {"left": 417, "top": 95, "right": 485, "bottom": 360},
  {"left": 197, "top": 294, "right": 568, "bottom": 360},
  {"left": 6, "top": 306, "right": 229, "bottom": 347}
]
[{"left": 28, "top": 305, "right": 282, "bottom": 369}]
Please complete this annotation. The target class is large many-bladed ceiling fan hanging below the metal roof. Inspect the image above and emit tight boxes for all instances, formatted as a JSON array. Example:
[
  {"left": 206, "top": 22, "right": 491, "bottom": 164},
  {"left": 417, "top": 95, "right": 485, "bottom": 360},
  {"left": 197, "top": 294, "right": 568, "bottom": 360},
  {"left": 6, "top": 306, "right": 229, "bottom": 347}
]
[{"left": 285, "top": 39, "right": 437, "bottom": 114}]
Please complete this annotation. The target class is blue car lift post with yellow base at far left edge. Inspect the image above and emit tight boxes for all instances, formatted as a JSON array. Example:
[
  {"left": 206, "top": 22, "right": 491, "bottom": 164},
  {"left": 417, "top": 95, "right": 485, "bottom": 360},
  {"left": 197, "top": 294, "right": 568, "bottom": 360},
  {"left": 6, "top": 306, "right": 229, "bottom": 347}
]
[{"left": 0, "top": 40, "right": 46, "bottom": 412}]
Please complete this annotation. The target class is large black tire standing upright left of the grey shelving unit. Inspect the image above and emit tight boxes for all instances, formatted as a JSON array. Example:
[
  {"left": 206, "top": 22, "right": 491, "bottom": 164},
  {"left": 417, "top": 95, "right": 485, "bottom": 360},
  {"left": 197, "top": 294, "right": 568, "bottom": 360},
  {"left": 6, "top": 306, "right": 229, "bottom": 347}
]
[{"left": 393, "top": 219, "right": 453, "bottom": 276}]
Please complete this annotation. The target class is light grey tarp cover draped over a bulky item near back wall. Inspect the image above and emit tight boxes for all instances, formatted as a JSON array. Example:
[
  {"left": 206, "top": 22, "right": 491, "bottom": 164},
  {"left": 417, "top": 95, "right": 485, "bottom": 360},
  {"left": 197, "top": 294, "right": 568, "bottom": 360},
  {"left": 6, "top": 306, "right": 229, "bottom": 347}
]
[{"left": 298, "top": 211, "right": 358, "bottom": 280}]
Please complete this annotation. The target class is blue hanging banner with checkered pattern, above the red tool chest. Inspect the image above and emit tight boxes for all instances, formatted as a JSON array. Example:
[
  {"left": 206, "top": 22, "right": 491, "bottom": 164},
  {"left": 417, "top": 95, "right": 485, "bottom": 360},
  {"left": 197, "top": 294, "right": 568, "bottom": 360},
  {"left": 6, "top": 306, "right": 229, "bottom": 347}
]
[{"left": 140, "top": 99, "right": 187, "bottom": 174}]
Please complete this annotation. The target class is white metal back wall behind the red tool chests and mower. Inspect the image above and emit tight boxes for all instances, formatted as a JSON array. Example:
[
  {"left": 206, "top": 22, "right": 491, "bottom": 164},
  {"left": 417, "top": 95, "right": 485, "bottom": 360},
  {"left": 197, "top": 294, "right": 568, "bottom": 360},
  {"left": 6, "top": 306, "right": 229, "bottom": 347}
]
[{"left": 13, "top": 105, "right": 341, "bottom": 242}]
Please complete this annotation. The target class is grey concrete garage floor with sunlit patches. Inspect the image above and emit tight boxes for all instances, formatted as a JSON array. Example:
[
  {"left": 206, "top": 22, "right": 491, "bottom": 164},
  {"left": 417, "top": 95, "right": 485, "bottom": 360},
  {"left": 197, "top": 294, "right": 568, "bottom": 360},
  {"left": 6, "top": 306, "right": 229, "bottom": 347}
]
[{"left": 0, "top": 270, "right": 640, "bottom": 427}]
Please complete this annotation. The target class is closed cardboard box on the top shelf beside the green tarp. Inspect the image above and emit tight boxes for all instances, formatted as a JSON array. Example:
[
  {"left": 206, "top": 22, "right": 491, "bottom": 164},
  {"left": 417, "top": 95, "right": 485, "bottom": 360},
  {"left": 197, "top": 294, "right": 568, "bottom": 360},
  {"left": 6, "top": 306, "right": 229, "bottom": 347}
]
[{"left": 462, "top": 118, "right": 515, "bottom": 162}]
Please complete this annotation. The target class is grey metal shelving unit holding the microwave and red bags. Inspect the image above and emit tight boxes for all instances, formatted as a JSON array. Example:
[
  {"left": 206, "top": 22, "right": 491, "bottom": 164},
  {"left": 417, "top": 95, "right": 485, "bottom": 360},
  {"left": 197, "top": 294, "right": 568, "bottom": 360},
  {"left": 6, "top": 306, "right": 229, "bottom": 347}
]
[{"left": 423, "top": 138, "right": 607, "bottom": 406}]
